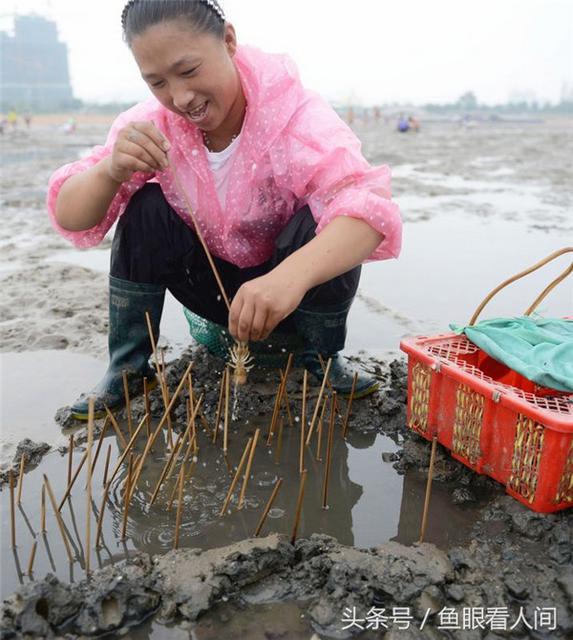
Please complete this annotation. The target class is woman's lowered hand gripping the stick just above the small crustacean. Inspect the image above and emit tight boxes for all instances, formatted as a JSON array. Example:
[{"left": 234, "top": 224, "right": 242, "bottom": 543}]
[{"left": 229, "top": 265, "right": 306, "bottom": 342}]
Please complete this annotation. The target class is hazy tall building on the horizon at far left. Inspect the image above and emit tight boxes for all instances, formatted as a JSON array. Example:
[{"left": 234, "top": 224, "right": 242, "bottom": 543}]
[{"left": 0, "top": 15, "right": 77, "bottom": 112}]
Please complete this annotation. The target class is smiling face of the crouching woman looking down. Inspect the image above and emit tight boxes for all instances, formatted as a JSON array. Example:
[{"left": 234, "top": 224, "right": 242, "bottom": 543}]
[{"left": 131, "top": 19, "right": 244, "bottom": 132}]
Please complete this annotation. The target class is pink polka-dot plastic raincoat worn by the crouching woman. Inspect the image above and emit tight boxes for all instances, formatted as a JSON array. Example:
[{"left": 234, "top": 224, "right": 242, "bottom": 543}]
[{"left": 48, "top": 46, "right": 402, "bottom": 268}]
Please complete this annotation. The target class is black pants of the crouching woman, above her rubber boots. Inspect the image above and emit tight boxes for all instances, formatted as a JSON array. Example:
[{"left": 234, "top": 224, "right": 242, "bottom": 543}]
[{"left": 110, "top": 183, "right": 361, "bottom": 332}]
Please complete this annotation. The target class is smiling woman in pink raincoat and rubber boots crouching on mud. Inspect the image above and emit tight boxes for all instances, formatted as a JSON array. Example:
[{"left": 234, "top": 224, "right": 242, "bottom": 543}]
[{"left": 48, "top": 0, "right": 402, "bottom": 419}]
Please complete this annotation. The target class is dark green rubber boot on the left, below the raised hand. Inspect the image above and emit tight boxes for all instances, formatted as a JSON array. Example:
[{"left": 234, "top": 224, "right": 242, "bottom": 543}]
[{"left": 71, "top": 276, "right": 165, "bottom": 420}]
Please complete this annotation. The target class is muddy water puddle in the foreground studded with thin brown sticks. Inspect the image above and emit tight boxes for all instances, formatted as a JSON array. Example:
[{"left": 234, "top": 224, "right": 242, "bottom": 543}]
[{"left": 1, "top": 398, "right": 492, "bottom": 595}]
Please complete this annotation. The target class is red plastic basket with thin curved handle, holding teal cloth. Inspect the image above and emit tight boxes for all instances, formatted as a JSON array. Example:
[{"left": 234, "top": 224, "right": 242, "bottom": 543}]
[{"left": 400, "top": 248, "right": 573, "bottom": 512}]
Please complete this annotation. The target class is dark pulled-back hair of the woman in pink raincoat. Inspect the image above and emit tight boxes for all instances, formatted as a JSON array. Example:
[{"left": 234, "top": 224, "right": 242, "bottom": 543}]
[{"left": 121, "top": 0, "right": 225, "bottom": 45}]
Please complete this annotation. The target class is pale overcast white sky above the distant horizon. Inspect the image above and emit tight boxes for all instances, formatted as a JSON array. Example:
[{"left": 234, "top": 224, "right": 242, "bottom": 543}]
[{"left": 0, "top": 0, "right": 573, "bottom": 105}]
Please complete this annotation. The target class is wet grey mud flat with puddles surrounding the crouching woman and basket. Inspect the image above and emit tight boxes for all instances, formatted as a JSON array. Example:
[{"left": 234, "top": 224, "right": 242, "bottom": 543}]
[{"left": 0, "top": 114, "right": 573, "bottom": 640}]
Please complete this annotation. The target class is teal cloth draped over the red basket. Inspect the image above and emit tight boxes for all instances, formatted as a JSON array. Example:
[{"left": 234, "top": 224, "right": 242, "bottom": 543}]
[{"left": 450, "top": 316, "right": 573, "bottom": 391}]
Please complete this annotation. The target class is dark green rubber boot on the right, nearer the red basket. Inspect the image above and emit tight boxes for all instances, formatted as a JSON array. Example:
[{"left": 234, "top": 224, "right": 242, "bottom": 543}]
[{"left": 294, "top": 300, "right": 380, "bottom": 398}]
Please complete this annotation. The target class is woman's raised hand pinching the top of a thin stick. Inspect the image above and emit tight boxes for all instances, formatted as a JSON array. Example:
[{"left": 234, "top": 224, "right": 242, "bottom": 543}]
[{"left": 108, "top": 122, "right": 171, "bottom": 183}]
